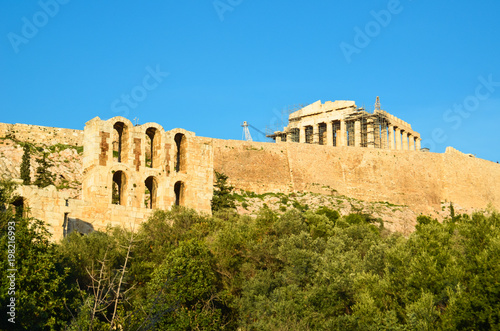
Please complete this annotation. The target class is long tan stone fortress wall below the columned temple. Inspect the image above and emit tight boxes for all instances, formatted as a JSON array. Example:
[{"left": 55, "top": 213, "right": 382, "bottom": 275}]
[{"left": 212, "top": 139, "right": 500, "bottom": 213}]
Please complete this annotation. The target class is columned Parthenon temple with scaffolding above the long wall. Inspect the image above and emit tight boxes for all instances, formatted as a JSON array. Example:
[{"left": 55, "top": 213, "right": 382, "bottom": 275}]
[{"left": 268, "top": 97, "right": 421, "bottom": 150}]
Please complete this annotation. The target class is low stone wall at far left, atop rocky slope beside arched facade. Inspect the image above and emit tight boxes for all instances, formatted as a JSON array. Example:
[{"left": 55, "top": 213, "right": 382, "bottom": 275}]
[{"left": 0, "top": 123, "right": 83, "bottom": 146}]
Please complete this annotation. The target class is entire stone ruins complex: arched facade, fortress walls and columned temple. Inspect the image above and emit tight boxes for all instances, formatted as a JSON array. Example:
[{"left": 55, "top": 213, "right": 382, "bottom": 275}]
[{"left": 0, "top": 101, "right": 500, "bottom": 240}]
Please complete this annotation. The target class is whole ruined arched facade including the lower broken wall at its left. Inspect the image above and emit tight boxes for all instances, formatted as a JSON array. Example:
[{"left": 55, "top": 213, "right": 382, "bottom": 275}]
[{"left": 11, "top": 117, "right": 214, "bottom": 240}]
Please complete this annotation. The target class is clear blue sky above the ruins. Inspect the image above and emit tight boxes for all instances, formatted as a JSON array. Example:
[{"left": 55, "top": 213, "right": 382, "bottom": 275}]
[{"left": 0, "top": 0, "right": 500, "bottom": 162}]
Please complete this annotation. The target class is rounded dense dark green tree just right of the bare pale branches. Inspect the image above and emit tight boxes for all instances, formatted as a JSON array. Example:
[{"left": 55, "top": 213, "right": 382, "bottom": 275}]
[{"left": 140, "top": 239, "right": 229, "bottom": 330}]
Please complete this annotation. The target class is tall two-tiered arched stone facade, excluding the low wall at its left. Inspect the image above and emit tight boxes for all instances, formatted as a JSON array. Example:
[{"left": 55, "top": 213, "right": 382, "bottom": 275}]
[{"left": 82, "top": 117, "right": 213, "bottom": 212}]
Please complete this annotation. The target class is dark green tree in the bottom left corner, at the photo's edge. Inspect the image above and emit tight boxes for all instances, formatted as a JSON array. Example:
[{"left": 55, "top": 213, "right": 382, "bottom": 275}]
[{"left": 0, "top": 182, "right": 78, "bottom": 330}]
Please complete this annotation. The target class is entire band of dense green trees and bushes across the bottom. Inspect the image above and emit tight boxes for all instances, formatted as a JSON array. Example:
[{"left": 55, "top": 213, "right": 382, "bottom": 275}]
[{"left": 0, "top": 183, "right": 500, "bottom": 330}]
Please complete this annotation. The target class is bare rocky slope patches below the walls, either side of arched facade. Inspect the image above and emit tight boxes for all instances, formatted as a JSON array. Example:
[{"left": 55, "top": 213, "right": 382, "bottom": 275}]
[{"left": 0, "top": 137, "right": 484, "bottom": 235}]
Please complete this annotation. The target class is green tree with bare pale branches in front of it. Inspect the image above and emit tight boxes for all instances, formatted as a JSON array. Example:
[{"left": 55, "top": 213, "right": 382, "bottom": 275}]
[{"left": 59, "top": 227, "right": 141, "bottom": 330}]
